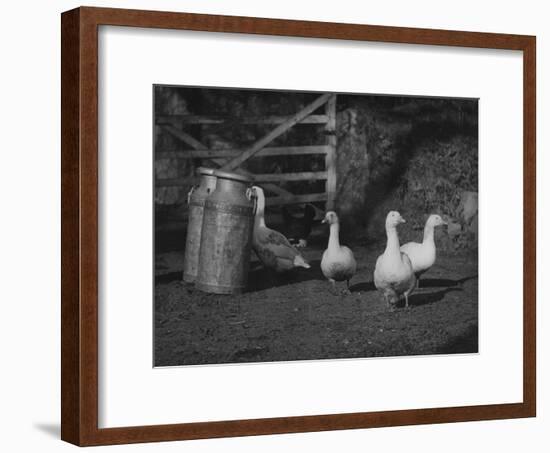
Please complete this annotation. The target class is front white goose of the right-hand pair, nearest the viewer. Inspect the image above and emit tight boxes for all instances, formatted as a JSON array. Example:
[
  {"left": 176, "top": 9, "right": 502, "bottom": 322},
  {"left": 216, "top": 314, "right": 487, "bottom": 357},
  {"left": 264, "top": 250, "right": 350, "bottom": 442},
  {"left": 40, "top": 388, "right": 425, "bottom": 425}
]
[{"left": 374, "top": 211, "right": 416, "bottom": 309}]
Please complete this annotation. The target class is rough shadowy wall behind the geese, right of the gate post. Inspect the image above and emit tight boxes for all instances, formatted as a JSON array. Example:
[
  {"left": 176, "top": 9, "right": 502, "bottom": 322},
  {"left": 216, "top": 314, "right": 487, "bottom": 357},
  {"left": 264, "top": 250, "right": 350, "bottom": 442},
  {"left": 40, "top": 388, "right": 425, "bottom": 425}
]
[{"left": 337, "top": 98, "right": 478, "bottom": 250}]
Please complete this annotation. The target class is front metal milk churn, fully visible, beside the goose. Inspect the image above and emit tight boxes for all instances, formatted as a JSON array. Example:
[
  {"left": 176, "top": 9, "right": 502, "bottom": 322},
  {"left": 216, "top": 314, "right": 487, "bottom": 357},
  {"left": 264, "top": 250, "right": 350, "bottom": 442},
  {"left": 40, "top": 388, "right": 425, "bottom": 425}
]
[{"left": 196, "top": 170, "right": 254, "bottom": 294}]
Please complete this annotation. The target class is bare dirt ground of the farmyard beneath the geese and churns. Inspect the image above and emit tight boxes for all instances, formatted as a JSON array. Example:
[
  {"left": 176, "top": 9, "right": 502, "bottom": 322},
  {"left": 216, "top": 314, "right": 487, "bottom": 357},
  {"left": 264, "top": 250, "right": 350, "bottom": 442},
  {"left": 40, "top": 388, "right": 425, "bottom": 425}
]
[{"left": 154, "top": 238, "right": 478, "bottom": 366}]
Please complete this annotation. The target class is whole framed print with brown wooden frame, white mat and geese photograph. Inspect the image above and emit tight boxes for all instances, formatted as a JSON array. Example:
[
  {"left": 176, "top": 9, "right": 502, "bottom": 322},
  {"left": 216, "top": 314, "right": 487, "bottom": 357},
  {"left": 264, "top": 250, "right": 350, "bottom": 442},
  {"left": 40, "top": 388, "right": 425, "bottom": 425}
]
[{"left": 62, "top": 7, "right": 536, "bottom": 445}]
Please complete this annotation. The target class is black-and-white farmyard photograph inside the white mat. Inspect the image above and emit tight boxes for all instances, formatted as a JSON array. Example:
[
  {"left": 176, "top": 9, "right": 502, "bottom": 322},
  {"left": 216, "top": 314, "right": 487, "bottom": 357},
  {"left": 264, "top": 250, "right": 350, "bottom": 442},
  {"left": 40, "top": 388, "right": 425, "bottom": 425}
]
[{"left": 152, "top": 85, "right": 478, "bottom": 367}]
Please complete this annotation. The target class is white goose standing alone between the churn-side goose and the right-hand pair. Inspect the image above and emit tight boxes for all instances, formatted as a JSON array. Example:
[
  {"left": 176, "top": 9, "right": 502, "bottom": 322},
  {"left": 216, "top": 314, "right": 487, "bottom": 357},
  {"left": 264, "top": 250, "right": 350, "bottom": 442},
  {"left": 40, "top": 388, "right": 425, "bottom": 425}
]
[{"left": 321, "top": 211, "right": 357, "bottom": 293}]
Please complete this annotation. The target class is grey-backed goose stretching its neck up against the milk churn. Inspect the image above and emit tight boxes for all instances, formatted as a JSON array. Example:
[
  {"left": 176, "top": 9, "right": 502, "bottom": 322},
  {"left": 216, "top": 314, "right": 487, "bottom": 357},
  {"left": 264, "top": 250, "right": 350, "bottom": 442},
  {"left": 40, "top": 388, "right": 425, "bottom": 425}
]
[{"left": 251, "top": 186, "right": 311, "bottom": 272}]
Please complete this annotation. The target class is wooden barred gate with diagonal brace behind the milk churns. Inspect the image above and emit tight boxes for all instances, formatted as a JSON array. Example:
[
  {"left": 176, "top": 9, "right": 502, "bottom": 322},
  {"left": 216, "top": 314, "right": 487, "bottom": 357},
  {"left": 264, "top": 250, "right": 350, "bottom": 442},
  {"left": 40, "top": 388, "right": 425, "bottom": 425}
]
[{"left": 155, "top": 93, "right": 336, "bottom": 210}]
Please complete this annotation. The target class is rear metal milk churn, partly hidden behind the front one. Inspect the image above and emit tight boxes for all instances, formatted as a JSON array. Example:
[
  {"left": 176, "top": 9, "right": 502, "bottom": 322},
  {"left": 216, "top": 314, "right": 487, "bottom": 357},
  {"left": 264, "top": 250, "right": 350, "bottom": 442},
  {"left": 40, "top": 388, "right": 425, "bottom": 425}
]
[{"left": 183, "top": 167, "right": 216, "bottom": 283}]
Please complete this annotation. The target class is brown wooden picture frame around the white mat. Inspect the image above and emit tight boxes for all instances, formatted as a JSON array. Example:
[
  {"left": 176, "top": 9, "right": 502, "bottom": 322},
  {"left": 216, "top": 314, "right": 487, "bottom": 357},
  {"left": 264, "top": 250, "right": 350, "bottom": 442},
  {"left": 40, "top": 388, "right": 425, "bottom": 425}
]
[{"left": 61, "top": 7, "right": 536, "bottom": 446}]
